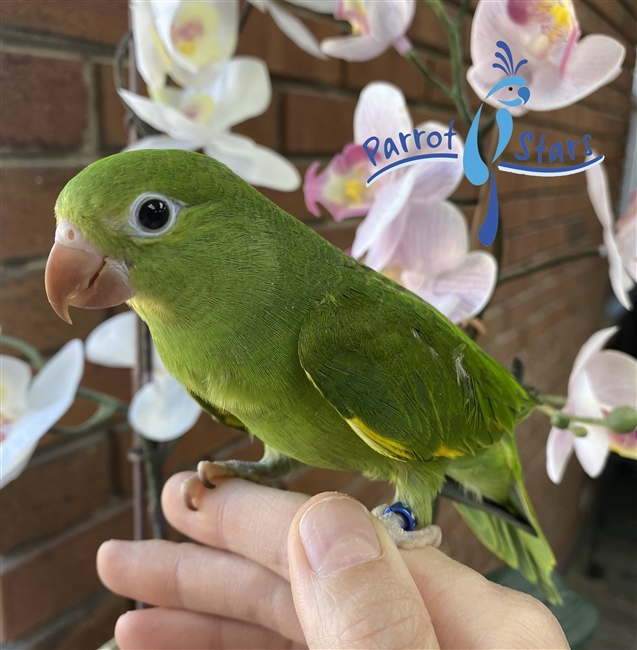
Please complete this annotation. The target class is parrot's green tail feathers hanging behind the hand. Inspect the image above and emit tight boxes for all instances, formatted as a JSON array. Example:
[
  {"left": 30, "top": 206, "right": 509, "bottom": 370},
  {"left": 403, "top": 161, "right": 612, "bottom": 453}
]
[{"left": 454, "top": 481, "right": 563, "bottom": 605}]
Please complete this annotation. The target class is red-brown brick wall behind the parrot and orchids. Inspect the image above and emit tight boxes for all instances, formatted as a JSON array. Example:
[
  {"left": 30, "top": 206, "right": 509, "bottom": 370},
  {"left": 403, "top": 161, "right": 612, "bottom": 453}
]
[{"left": 0, "top": 0, "right": 636, "bottom": 648}]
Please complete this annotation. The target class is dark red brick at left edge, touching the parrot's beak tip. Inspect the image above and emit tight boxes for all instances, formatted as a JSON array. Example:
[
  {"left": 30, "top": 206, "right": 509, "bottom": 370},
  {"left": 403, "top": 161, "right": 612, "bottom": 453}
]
[{"left": 0, "top": 273, "right": 104, "bottom": 350}]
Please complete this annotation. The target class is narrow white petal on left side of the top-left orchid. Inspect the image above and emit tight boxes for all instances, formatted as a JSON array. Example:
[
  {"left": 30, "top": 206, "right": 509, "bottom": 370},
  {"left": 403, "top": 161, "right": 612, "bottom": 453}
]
[{"left": 130, "top": 0, "right": 170, "bottom": 88}]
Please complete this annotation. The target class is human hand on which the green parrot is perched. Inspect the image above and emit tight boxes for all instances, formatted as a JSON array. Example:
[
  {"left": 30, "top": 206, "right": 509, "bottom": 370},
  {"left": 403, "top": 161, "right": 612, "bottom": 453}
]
[{"left": 97, "top": 474, "right": 568, "bottom": 650}]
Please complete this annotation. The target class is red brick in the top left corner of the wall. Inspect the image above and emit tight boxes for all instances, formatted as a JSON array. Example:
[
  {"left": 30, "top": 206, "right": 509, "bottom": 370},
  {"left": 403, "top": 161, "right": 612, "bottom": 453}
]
[{"left": 2, "top": 0, "right": 128, "bottom": 45}]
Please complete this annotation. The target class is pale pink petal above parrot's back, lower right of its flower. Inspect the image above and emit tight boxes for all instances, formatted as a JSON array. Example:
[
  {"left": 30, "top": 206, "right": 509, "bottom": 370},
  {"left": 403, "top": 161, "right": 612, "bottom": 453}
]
[{"left": 432, "top": 251, "right": 498, "bottom": 323}]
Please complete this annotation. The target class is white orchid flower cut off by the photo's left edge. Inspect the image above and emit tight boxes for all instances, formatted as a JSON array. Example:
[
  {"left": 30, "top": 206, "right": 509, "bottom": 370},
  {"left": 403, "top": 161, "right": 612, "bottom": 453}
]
[{"left": 0, "top": 339, "right": 84, "bottom": 488}]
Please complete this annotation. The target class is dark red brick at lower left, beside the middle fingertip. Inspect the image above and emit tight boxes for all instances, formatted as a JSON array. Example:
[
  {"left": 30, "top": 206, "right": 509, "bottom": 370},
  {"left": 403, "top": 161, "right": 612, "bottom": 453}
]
[{"left": 0, "top": 506, "right": 132, "bottom": 641}]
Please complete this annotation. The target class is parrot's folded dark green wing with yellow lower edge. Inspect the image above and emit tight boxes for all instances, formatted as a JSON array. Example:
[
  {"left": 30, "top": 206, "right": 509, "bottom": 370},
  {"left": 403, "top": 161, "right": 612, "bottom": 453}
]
[{"left": 299, "top": 276, "right": 526, "bottom": 460}]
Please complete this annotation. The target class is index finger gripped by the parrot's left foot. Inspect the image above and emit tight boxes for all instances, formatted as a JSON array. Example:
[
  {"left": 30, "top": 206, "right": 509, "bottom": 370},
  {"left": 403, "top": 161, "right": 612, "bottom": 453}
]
[{"left": 162, "top": 472, "right": 310, "bottom": 580}]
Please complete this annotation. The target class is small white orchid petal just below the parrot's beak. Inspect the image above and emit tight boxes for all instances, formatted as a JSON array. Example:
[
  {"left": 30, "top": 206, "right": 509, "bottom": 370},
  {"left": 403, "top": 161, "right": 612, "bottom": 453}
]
[{"left": 85, "top": 311, "right": 137, "bottom": 368}]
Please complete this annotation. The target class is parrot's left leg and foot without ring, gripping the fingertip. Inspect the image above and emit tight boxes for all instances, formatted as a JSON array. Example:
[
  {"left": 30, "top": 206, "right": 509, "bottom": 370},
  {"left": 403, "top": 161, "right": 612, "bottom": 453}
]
[{"left": 181, "top": 445, "right": 303, "bottom": 510}]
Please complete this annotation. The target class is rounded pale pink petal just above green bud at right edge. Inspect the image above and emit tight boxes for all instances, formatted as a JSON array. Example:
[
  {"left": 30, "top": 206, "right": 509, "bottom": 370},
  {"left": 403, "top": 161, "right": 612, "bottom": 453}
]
[{"left": 585, "top": 350, "right": 637, "bottom": 409}]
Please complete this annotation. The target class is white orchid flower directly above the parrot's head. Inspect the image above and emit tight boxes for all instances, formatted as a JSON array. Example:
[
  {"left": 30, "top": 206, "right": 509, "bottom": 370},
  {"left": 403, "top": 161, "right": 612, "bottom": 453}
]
[{"left": 119, "top": 57, "right": 301, "bottom": 191}]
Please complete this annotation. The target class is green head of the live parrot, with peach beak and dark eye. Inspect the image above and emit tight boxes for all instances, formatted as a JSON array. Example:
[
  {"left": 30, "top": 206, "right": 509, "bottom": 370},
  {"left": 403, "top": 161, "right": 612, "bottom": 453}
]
[{"left": 45, "top": 150, "right": 238, "bottom": 323}]
